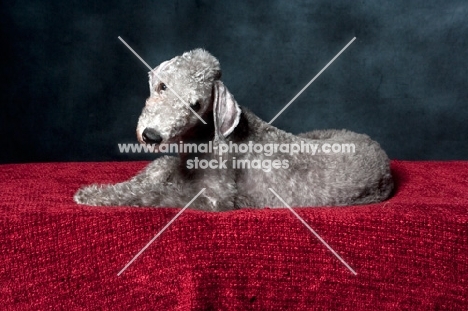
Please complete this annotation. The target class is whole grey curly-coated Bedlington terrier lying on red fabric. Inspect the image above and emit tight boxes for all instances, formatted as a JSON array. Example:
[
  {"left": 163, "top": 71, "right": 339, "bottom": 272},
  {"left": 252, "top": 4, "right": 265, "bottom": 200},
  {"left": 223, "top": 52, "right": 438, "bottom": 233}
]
[{"left": 74, "top": 49, "right": 393, "bottom": 211}]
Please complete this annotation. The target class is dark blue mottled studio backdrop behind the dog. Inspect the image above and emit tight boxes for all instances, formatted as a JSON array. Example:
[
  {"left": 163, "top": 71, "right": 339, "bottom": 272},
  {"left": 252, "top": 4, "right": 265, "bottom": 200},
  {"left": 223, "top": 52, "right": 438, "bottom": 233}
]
[{"left": 0, "top": 0, "right": 468, "bottom": 163}]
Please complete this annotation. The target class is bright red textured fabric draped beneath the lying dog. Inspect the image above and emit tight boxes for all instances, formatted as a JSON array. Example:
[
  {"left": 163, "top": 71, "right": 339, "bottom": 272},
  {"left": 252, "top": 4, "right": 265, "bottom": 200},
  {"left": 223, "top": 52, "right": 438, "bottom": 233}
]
[{"left": 0, "top": 161, "right": 468, "bottom": 310}]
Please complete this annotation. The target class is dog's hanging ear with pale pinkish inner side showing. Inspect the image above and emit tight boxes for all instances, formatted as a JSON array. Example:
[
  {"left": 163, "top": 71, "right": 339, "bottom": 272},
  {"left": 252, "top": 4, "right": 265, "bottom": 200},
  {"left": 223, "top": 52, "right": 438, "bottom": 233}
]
[{"left": 213, "top": 81, "right": 241, "bottom": 139}]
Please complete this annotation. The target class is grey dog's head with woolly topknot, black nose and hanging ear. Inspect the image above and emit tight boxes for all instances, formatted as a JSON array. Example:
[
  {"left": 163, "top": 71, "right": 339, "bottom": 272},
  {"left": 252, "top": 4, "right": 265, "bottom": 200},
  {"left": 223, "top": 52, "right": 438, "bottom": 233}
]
[{"left": 137, "top": 49, "right": 241, "bottom": 144}]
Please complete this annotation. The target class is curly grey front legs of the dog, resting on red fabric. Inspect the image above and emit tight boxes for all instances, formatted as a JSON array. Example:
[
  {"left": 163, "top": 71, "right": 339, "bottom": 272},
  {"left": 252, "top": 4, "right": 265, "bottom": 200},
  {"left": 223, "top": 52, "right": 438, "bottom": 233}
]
[{"left": 74, "top": 156, "right": 236, "bottom": 211}]
